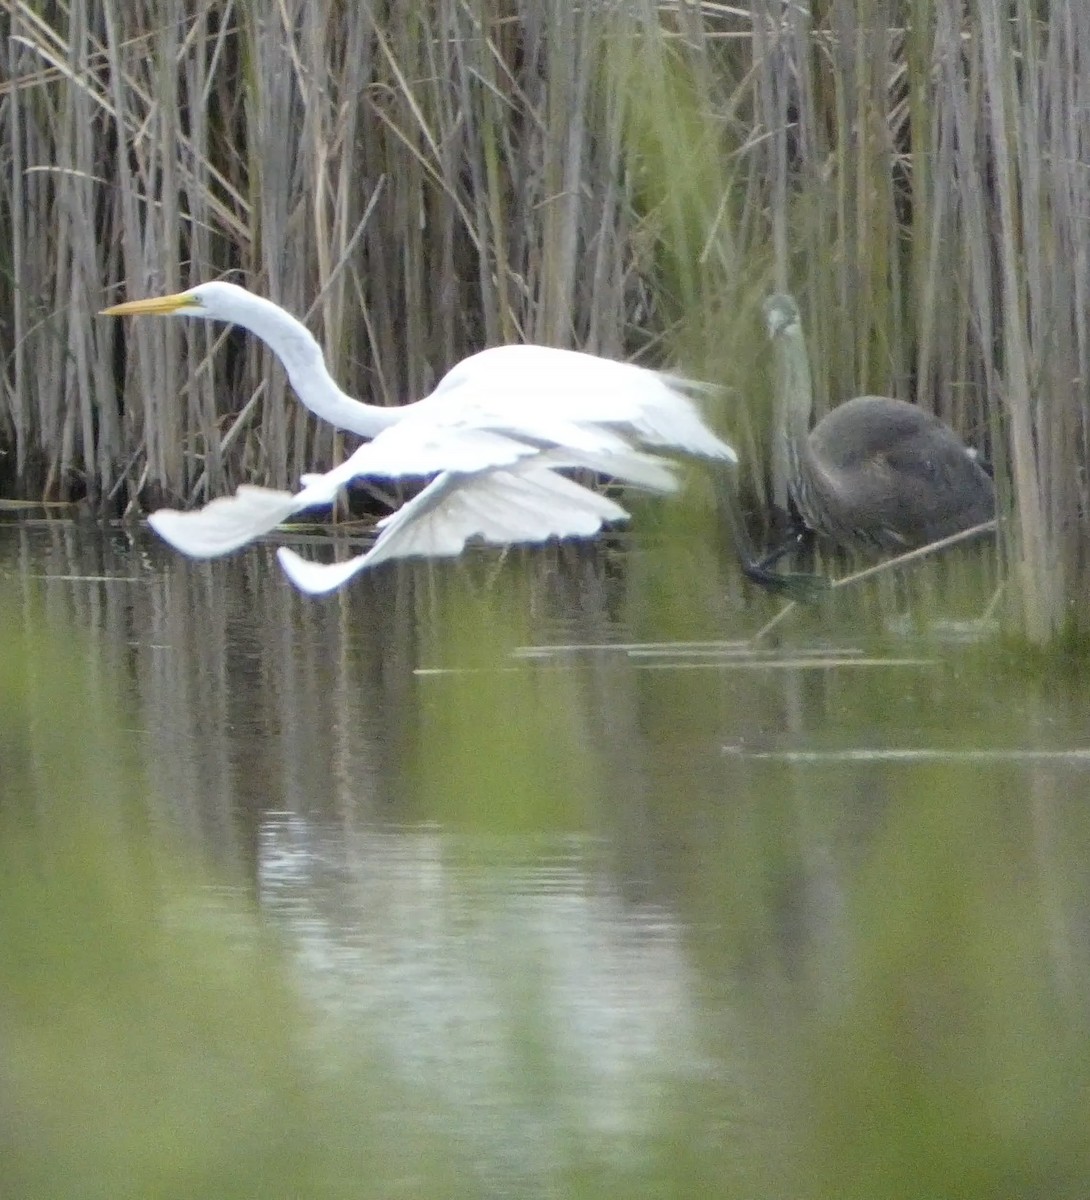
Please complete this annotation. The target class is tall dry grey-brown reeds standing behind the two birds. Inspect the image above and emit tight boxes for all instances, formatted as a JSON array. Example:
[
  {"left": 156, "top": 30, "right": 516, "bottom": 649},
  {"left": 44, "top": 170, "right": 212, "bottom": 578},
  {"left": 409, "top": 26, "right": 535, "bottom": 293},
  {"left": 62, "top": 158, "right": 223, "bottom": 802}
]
[{"left": 0, "top": 0, "right": 1090, "bottom": 643}]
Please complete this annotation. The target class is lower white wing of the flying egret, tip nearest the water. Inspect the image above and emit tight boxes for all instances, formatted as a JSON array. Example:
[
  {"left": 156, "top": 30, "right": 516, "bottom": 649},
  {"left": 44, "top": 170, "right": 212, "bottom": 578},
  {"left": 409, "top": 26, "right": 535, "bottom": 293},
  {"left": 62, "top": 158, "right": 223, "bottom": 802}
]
[{"left": 276, "top": 461, "right": 628, "bottom": 595}]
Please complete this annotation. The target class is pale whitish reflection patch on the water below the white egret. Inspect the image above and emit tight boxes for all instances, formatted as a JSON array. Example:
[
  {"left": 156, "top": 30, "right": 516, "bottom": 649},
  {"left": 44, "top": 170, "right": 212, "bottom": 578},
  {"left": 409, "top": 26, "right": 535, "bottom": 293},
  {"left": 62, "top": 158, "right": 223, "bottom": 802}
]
[{"left": 260, "top": 814, "right": 699, "bottom": 1171}]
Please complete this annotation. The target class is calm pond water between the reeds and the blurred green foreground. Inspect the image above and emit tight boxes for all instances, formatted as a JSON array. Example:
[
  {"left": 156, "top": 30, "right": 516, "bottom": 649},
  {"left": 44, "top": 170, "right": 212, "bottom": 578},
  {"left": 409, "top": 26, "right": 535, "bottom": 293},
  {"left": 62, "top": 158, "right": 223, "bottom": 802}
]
[{"left": 0, "top": 522, "right": 1090, "bottom": 1190}]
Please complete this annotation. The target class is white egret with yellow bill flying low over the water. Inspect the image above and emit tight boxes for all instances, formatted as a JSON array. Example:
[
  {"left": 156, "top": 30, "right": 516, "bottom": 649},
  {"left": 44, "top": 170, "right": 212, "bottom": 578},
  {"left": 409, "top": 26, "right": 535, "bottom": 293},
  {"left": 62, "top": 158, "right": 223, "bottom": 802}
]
[{"left": 103, "top": 282, "right": 760, "bottom": 592}]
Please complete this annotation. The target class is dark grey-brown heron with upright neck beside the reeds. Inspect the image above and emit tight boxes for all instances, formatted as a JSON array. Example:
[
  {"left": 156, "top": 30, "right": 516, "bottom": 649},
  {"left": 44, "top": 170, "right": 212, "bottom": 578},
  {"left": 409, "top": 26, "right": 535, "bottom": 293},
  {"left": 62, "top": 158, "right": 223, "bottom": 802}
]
[{"left": 761, "top": 295, "right": 995, "bottom": 569}]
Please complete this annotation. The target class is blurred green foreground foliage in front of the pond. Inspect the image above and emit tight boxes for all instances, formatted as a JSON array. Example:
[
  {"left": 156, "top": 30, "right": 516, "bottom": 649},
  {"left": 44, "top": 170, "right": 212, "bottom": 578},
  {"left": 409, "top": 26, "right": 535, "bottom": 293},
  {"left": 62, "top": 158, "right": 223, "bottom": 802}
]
[{"left": 0, "top": 590, "right": 1090, "bottom": 1200}]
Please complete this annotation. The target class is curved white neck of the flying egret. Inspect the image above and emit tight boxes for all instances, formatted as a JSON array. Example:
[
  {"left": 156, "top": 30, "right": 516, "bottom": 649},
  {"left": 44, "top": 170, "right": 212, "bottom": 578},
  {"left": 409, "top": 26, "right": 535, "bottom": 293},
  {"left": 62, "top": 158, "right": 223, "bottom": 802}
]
[{"left": 212, "top": 293, "right": 405, "bottom": 438}]
